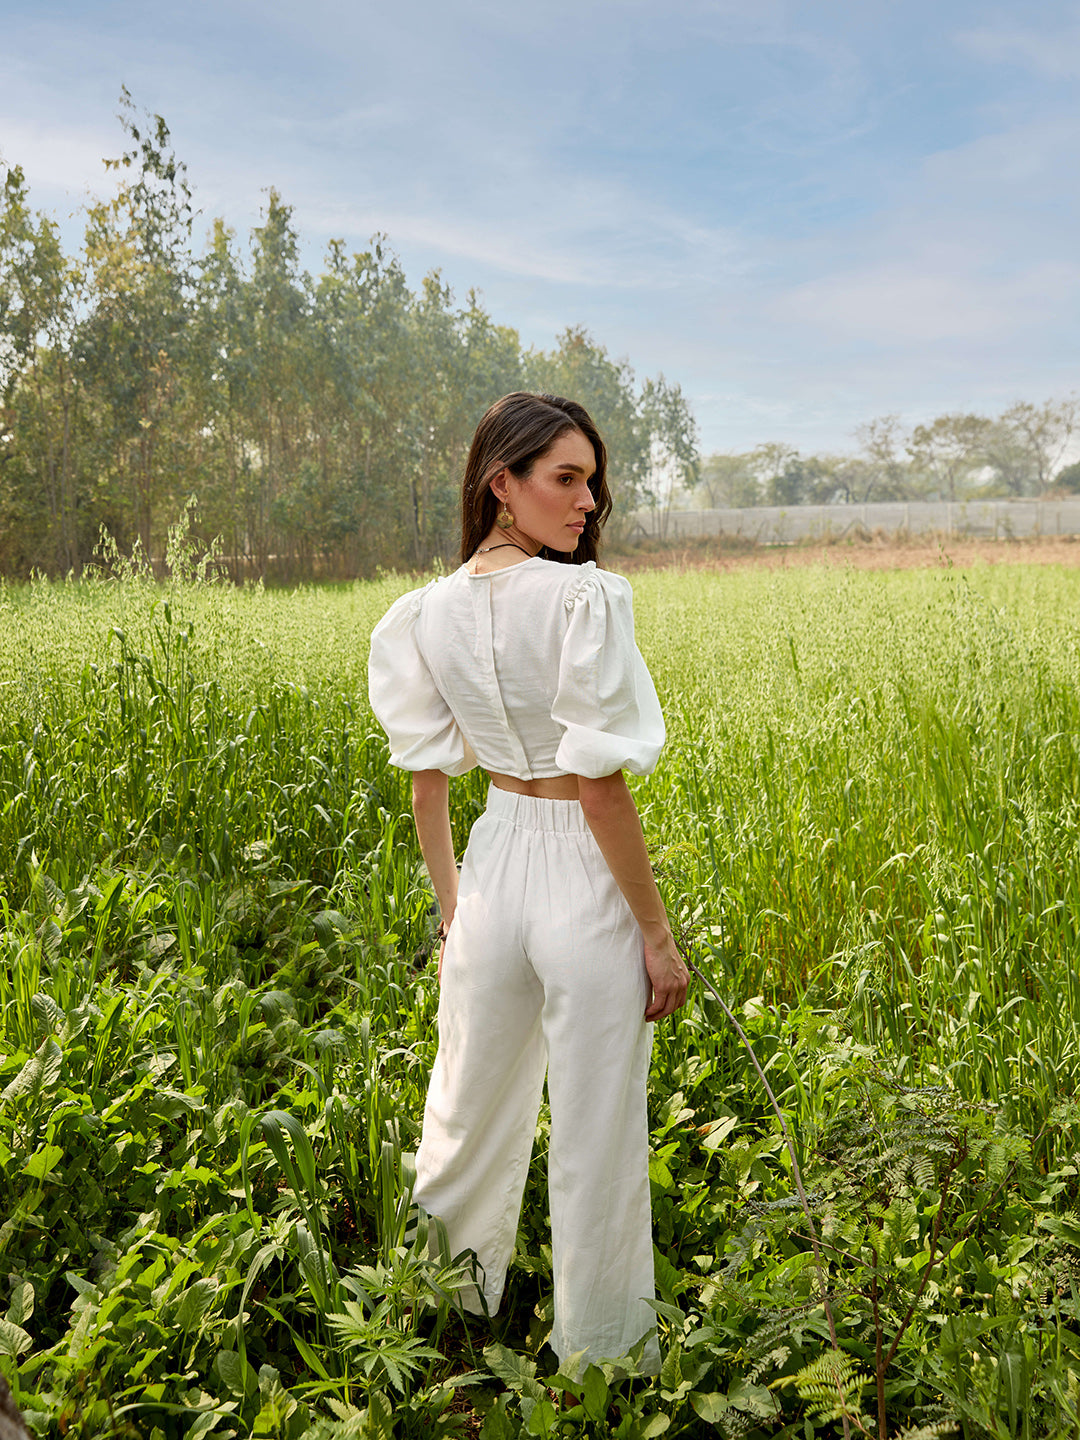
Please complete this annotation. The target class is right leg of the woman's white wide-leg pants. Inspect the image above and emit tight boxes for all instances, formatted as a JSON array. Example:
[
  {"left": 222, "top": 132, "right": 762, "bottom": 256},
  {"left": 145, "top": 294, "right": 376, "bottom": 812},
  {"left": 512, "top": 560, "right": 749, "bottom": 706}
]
[{"left": 524, "top": 806, "right": 660, "bottom": 1369}]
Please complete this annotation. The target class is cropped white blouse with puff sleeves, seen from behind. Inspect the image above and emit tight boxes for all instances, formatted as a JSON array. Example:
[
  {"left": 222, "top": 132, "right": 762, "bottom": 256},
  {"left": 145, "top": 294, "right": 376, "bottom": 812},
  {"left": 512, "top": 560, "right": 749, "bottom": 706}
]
[{"left": 367, "top": 557, "right": 664, "bottom": 780}]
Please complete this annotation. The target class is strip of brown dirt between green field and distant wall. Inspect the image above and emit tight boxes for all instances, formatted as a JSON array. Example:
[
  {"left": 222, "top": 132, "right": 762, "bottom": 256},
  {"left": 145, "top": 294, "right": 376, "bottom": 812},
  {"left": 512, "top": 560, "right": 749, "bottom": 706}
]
[{"left": 603, "top": 536, "right": 1080, "bottom": 575}]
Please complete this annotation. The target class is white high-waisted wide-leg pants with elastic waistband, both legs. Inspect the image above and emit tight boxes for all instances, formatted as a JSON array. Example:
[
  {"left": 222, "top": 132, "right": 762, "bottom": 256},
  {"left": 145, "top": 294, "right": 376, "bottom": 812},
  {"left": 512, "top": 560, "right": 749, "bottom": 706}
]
[{"left": 415, "top": 786, "right": 658, "bottom": 1368}]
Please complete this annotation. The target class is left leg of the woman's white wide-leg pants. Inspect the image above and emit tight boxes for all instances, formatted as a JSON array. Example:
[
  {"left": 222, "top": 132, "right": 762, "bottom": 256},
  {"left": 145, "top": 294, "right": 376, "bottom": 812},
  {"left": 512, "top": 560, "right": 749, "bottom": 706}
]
[{"left": 413, "top": 814, "right": 547, "bottom": 1313}]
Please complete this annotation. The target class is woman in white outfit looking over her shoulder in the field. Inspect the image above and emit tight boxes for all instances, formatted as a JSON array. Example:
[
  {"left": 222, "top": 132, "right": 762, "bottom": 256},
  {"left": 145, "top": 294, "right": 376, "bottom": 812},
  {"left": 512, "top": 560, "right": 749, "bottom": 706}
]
[{"left": 369, "top": 393, "right": 688, "bottom": 1369}]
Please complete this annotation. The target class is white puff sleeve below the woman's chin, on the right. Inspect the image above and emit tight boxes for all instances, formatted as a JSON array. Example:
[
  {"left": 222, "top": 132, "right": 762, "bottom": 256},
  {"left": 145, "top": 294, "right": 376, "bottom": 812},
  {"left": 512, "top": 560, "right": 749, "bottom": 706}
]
[{"left": 552, "top": 567, "right": 664, "bottom": 779}]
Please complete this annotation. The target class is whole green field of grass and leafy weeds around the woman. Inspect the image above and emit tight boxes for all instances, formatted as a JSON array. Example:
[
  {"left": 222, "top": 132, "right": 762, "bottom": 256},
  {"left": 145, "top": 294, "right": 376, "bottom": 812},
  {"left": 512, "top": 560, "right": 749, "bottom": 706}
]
[{"left": 0, "top": 552, "right": 1080, "bottom": 1440}]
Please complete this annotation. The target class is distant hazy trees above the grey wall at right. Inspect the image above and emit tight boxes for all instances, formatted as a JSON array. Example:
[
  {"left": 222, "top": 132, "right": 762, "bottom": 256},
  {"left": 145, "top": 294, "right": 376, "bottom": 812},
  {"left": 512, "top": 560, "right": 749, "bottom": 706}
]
[{"left": 691, "top": 396, "right": 1080, "bottom": 510}]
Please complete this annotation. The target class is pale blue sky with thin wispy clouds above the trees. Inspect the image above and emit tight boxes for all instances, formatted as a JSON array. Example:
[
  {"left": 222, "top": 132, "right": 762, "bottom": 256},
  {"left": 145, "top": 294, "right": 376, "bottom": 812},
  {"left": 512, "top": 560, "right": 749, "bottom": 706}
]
[{"left": 0, "top": 0, "right": 1080, "bottom": 452}]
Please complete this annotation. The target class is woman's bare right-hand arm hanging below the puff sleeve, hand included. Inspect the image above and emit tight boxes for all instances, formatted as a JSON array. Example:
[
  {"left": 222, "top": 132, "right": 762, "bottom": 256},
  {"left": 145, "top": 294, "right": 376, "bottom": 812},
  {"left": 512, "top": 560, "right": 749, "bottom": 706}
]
[{"left": 577, "top": 770, "right": 690, "bottom": 1020}]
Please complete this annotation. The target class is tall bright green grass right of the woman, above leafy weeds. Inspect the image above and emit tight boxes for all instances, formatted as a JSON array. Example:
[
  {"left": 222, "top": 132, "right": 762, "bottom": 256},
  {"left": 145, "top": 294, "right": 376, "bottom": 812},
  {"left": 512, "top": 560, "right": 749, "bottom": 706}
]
[{"left": 638, "top": 567, "right": 1080, "bottom": 1159}]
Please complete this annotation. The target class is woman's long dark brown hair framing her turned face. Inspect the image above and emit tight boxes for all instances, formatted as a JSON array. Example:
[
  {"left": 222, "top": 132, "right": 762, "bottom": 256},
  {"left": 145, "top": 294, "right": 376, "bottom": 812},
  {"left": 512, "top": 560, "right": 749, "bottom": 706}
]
[{"left": 461, "top": 390, "right": 611, "bottom": 564}]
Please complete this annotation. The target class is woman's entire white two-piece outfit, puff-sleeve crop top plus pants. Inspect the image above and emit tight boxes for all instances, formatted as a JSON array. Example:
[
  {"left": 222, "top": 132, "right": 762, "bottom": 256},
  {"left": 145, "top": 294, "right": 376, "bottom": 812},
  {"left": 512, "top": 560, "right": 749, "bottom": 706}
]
[{"left": 369, "top": 559, "right": 664, "bottom": 1371}]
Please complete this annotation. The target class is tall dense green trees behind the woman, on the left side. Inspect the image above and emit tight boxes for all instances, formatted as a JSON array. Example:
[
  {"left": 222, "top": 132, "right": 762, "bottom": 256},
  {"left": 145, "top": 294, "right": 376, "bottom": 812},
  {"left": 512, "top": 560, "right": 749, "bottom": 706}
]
[{"left": 0, "top": 91, "right": 697, "bottom": 579}]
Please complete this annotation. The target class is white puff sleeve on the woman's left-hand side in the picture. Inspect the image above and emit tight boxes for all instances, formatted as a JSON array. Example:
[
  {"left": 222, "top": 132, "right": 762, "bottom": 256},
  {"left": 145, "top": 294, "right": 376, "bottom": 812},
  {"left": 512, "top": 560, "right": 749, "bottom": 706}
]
[{"left": 367, "top": 586, "right": 477, "bottom": 775}]
